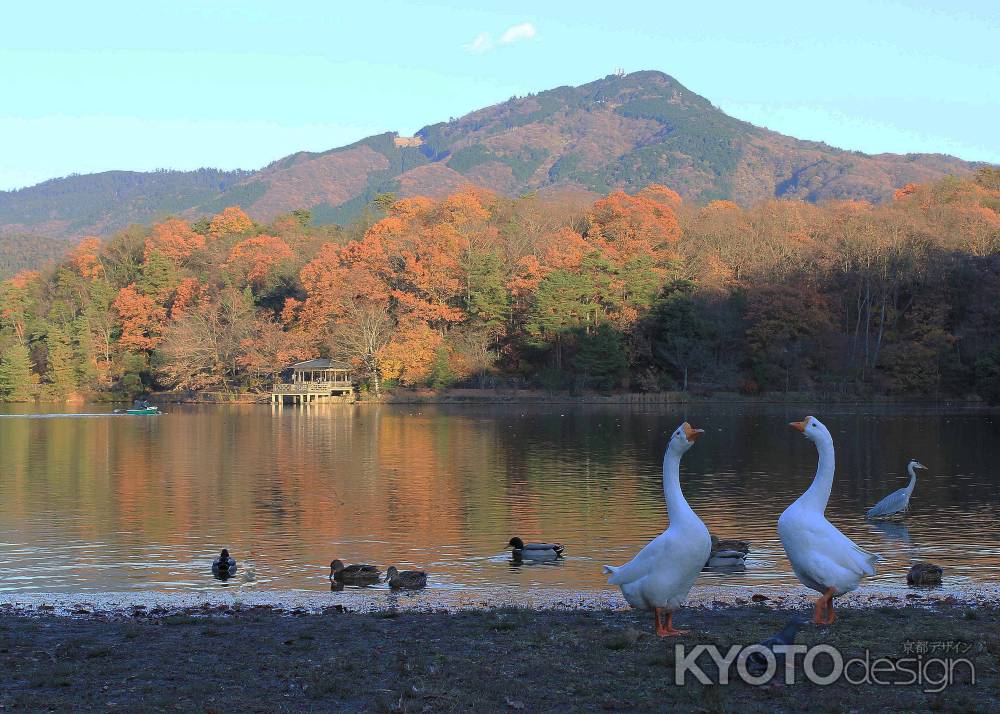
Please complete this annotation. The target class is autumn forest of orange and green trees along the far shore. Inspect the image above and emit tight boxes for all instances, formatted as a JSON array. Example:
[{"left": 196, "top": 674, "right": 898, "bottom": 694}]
[{"left": 0, "top": 168, "right": 1000, "bottom": 403}]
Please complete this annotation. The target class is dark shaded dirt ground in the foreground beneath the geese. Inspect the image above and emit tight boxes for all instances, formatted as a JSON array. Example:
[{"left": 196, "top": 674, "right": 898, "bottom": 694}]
[{"left": 0, "top": 603, "right": 1000, "bottom": 712}]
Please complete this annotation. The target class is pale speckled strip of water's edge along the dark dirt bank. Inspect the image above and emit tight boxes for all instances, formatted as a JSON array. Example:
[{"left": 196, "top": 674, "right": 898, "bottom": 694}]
[{"left": 0, "top": 583, "right": 1000, "bottom": 618}]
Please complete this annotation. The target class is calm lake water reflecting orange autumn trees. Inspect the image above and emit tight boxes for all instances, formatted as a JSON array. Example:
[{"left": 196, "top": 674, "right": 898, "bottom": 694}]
[{"left": 0, "top": 404, "right": 1000, "bottom": 592}]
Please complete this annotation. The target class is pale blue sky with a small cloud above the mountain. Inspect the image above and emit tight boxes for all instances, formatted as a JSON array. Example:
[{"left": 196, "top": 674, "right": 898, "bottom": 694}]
[{"left": 0, "top": 0, "right": 1000, "bottom": 190}]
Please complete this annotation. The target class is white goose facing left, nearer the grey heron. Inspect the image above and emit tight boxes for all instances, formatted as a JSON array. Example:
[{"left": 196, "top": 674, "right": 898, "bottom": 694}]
[{"left": 778, "top": 416, "right": 878, "bottom": 625}]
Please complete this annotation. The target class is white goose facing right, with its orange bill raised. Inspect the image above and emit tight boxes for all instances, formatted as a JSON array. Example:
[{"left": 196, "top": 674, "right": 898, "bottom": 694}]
[{"left": 604, "top": 422, "right": 712, "bottom": 637}]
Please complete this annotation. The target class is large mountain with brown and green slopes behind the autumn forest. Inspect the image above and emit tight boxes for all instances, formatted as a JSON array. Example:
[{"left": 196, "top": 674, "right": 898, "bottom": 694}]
[{"left": 0, "top": 71, "right": 983, "bottom": 250}]
